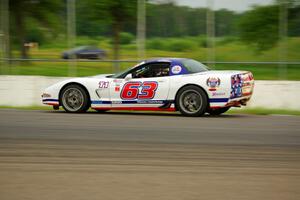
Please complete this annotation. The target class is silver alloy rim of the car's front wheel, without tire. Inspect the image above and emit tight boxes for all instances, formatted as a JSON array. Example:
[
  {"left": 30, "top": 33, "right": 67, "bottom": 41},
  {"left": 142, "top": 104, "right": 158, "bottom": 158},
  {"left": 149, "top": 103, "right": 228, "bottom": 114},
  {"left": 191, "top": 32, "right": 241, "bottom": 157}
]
[{"left": 62, "top": 88, "right": 84, "bottom": 112}]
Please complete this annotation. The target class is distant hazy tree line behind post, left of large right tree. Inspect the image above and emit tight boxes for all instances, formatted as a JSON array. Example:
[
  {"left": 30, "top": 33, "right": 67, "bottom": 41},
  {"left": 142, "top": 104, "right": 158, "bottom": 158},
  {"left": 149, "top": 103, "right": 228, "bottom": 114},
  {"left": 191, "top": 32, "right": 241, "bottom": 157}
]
[{"left": 147, "top": 2, "right": 241, "bottom": 37}]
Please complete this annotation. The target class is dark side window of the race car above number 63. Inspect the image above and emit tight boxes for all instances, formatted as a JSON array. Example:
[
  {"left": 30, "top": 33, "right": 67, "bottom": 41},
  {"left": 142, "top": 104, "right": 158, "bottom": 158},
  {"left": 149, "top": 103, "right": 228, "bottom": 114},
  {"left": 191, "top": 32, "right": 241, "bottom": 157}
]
[{"left": 132, "top": 63, "right": 170, "bottom": 78}]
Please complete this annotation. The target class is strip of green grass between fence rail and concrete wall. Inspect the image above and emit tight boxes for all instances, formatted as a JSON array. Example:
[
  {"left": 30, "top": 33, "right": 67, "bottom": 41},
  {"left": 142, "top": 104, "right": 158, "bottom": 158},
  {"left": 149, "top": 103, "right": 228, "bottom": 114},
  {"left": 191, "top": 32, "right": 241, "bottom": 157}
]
[{"left": 3, "top": 59, "right": 300, "bottom": 80}]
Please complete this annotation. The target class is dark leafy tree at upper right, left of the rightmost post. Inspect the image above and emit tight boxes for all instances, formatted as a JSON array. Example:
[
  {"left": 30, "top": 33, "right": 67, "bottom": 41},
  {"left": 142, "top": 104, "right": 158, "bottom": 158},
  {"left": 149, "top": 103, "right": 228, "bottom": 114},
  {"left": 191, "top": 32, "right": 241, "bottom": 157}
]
[{"left": 239, "top": 5, "right": 279, "bottom": 50}]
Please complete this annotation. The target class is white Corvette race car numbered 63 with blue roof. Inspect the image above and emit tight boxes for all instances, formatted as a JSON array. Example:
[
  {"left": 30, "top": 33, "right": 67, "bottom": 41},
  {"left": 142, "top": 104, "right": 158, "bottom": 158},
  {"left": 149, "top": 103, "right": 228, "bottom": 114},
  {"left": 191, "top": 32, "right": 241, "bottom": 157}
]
[{"left": 42, "top": 58, "right": 254, "bottom": 116}]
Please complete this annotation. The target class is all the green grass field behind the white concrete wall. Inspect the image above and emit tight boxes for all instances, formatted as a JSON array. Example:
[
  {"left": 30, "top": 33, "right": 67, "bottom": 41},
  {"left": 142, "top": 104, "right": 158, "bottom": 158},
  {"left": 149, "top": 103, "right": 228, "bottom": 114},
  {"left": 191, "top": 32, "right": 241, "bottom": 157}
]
[{"left": 0, "top": 37, "right": 300, "bottom": 80}]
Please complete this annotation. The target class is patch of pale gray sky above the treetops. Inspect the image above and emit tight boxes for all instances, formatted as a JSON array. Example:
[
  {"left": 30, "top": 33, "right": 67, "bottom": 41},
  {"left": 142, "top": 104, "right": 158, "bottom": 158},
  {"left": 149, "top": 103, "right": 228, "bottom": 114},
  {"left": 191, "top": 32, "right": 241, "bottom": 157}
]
[{"left": 174, "top": 0, "right": 274, "bottom": 12}]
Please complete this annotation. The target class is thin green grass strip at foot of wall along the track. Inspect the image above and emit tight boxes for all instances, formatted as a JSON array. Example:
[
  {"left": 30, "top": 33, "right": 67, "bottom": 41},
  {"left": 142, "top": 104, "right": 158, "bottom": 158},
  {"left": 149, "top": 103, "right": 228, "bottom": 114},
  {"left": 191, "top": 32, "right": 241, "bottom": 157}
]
[{"left": 0, "top": 106, "right": 300, "bottom": 116}]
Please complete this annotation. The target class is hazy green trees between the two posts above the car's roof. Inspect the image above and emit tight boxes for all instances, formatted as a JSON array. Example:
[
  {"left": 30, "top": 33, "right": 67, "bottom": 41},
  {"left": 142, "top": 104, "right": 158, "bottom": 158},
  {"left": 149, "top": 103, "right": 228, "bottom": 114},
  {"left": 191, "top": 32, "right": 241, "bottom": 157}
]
[{"left": 147, "top": 2, "right": 206, "bottom": 37}]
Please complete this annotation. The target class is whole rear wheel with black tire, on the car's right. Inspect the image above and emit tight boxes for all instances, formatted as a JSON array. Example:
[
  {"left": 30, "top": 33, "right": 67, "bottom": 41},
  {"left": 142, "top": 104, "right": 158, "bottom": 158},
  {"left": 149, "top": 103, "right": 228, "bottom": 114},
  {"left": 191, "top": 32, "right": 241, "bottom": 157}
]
[{"left": 176, "top": 85, "right": 208, "bottom": 117}]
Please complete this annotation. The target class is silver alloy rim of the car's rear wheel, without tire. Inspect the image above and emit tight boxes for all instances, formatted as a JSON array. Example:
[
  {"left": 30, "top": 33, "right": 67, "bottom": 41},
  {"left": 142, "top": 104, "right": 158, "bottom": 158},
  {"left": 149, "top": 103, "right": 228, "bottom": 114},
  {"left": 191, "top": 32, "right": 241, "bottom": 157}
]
[{"left": 179, "top": 90, "right": 202, "bottom": 114}]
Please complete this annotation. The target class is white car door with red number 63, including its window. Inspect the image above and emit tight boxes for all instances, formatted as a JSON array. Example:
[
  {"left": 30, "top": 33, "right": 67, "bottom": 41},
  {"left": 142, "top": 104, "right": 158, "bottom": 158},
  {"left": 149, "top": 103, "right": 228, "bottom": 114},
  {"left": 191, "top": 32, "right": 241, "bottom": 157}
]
[{"left": 110, "top": 63, "right": 170, "bottom": 108}]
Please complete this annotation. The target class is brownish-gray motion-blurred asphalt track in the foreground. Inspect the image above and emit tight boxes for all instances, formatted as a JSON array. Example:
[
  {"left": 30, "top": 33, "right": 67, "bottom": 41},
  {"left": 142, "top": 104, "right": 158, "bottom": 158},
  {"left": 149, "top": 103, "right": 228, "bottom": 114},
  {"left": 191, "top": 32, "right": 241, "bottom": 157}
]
[{"left": 0, "top": 109, "right": 300, "bottom": 200}]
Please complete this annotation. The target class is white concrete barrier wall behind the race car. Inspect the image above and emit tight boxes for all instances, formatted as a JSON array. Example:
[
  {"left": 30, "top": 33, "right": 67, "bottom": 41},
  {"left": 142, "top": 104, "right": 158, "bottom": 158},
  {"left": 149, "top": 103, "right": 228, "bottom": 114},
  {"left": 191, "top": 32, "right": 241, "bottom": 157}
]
[{"left": 0, "top": 76, "right": 300, "bottom": 110}]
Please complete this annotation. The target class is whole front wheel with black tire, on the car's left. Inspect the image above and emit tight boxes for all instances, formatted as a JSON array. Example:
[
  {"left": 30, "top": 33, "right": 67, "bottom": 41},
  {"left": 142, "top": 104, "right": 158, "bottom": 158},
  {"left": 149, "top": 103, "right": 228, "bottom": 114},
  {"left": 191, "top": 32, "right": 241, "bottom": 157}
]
[{"left": 60, "top": 84, "right": 90, "bottom": 113}]
